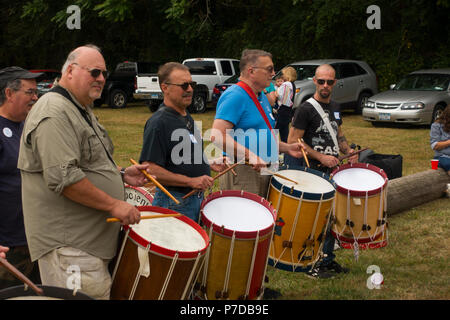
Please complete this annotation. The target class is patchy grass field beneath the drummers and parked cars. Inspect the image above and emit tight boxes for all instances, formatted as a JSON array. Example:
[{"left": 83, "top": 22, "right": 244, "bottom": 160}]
[{"left": 95, "top": 104, "right": 450, "bottom": 300}]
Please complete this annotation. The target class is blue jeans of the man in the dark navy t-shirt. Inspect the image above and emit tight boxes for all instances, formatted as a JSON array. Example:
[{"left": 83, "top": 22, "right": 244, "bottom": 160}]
[{"left": 152, "top": 188, "right": 203, "bottom": 223}]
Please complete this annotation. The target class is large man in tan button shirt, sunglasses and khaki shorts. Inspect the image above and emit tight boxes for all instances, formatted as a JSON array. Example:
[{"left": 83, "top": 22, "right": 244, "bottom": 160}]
[{"left": 18, "top": 45, "right": 148, "bottom": 299}]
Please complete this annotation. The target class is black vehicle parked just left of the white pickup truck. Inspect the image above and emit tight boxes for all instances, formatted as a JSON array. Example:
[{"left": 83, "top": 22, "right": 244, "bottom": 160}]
[{"left": 95, "top": 61, "right": 159, "bottom": 108}]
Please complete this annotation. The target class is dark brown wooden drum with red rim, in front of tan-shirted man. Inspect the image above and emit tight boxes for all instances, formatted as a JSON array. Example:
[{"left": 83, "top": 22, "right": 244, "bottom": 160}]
[{"left": 111, "top": 206, "right": 209, "bottom": 300}]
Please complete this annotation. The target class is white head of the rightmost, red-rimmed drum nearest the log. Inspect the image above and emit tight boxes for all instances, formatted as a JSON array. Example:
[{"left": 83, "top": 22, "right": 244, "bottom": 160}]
[{"left": 333, "top": 168, "right": 385, "bottom": 191}]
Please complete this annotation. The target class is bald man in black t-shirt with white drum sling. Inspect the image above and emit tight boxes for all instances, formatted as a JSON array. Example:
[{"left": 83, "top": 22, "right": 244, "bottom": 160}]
[{"left": 284, "top": 64, "right": 358, "bottom": 278}]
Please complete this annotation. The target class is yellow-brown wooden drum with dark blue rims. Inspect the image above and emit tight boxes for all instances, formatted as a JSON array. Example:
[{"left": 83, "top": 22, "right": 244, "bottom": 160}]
[{"left": 267, "top": 168, "right": 336, "bottom": 272}]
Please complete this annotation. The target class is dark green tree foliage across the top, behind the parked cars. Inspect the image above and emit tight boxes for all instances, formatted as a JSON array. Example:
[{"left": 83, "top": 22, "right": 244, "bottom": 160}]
[{"left": 0, "top": 0, "right": 450, "bottom": 89}]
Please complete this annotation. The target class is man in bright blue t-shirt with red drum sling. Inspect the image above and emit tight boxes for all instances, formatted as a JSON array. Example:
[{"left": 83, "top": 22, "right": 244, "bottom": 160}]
[{"left": 211, "top": 49, "right": 302, "bottom": 197}]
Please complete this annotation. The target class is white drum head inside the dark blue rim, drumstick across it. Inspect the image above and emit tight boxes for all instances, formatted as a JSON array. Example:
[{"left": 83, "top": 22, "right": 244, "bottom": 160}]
[{"left": 273, "top": 170, "right": 334, "bottom": 193}]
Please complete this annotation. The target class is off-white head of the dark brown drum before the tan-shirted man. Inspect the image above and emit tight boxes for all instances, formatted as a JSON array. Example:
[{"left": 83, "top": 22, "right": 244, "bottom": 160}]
[{"left": 131, "top": 211, "right": 206, "bottom": 252}]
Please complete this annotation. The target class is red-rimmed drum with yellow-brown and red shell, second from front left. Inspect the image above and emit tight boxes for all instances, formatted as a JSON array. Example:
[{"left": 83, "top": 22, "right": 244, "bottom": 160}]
[{"left": 198, "top": 190, "right": 276, "bottom": 300}]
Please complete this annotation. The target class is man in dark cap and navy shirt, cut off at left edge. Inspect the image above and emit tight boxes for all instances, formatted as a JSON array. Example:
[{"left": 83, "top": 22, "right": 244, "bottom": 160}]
[{"left": 0, "top": 67, "right": 42, "bottom": 289}]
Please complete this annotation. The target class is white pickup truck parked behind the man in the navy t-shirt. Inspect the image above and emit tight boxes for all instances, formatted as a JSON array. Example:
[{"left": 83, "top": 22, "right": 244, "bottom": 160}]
[{"left": 133, "top": 58, "right": 239, "bottom": 113}]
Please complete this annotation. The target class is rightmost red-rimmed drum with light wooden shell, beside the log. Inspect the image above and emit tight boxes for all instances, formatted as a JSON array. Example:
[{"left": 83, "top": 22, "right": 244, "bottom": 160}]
[{"left": 331, "top": 163, "right": 388, "bottom": 243}]
